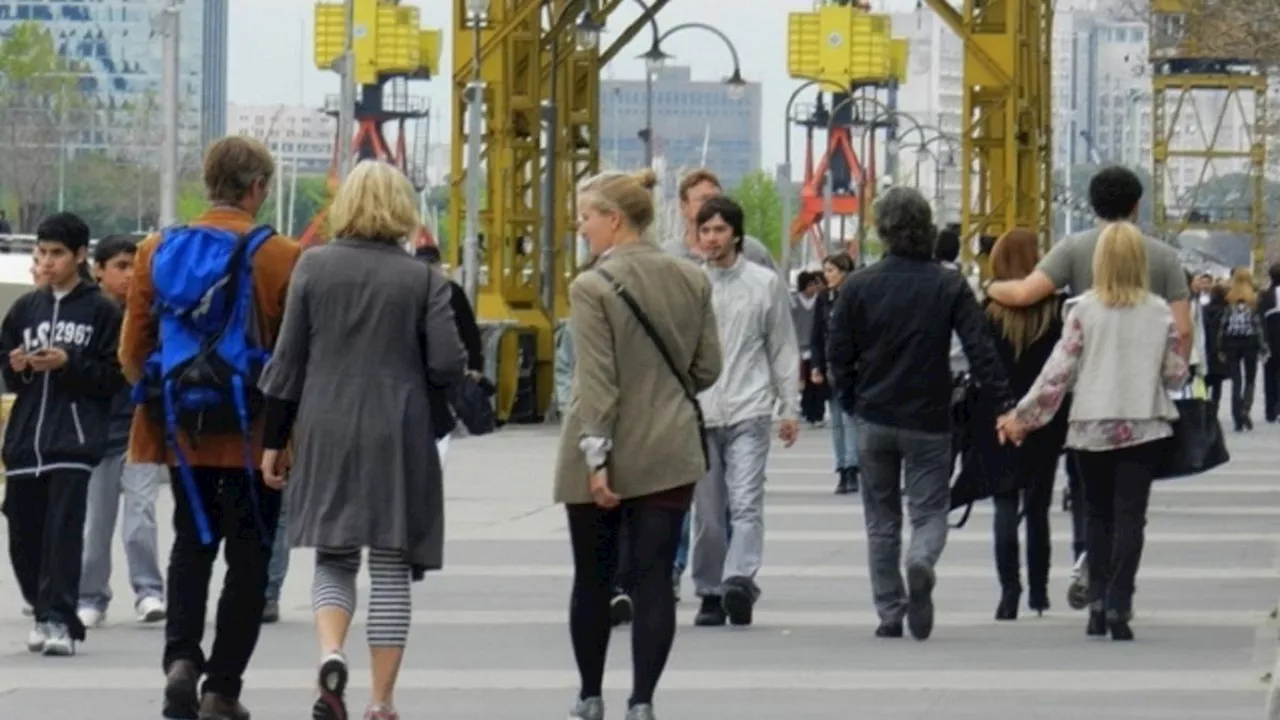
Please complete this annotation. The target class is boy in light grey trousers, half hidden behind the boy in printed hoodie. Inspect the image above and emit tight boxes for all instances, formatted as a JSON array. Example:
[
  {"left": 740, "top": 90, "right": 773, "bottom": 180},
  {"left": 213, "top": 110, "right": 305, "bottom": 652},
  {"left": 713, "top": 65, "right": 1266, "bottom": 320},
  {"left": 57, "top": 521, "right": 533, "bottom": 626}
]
[{"left": 79, "top": 234, "right": 165, "bottom": 628}]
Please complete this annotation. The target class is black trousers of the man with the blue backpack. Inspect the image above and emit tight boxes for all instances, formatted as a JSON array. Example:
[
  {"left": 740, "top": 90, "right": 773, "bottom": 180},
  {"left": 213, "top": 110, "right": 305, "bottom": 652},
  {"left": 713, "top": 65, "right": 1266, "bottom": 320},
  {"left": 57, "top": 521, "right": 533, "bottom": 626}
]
[{"left": 163, "top": 468, "right": 280, "bottom": 698}]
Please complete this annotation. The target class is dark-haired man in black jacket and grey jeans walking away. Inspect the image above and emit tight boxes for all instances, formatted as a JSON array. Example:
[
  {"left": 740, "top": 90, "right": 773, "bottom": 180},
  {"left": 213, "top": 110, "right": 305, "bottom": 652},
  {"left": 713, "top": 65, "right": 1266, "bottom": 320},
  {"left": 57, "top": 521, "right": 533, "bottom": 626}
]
[{"left": 827, "top": 187, "right": 1015, "bottom": 641}]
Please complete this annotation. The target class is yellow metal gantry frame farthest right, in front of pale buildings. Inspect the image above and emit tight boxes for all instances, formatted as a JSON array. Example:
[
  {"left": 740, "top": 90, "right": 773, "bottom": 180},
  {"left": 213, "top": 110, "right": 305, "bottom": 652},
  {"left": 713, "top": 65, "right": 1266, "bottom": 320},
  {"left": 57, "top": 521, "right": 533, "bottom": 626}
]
[{"left": 1149, "top": 0, "right": 1267, "bottom": 275}]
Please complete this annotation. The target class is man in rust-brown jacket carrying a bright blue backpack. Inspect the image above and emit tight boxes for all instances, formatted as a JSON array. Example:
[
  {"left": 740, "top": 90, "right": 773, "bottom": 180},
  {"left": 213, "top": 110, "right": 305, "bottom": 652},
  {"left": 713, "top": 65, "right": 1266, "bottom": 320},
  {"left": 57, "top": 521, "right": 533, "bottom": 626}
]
[{"left": 120, "top": 137, "right": 300, "bottom": 720}]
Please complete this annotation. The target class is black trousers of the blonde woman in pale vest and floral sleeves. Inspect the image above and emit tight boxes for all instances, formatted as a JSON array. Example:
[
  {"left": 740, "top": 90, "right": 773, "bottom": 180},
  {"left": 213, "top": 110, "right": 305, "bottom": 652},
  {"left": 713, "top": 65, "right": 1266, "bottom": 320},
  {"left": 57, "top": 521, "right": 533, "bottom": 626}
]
[{"left": 1079, "top": 442, "right": 1160, "bottom": 612}]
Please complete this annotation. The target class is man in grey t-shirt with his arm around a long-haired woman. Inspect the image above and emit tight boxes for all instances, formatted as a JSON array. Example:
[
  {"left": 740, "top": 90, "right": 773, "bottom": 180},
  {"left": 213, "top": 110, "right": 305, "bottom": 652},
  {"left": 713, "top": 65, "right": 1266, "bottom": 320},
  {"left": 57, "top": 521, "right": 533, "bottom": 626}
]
[{"left": 987, "top": 167, "right": 1192, "bottom": 356}]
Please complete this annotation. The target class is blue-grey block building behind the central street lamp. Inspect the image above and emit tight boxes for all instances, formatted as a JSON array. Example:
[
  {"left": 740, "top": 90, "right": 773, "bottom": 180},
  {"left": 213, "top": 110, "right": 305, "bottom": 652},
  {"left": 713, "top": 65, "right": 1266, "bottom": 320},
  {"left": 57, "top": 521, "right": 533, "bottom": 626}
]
[{"left": 599, "top": 67, "right": 757, "bottom": 187}]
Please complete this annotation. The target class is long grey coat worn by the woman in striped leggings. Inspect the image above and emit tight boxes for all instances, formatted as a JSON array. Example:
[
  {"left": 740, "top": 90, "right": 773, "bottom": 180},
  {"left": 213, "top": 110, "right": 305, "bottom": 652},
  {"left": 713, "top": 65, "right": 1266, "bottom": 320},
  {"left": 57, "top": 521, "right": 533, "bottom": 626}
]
[{"left": 260, "top": 240, "right": 466, "bottom": 577}]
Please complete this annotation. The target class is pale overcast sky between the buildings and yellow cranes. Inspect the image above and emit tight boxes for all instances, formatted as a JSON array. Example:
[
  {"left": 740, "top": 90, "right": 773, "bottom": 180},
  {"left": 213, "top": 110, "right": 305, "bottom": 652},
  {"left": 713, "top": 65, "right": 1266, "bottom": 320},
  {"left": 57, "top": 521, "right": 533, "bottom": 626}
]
[{"left": 228, "top": 0, "right": 928, "bottom": 169}]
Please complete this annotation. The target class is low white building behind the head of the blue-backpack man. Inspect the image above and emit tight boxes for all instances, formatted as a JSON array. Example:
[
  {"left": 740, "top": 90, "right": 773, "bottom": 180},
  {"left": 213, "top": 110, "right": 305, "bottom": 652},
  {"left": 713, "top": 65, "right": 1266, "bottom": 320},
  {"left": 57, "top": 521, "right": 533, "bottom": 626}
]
[{"left": 227, "top": 102, "right": 338, "bottom": 174}]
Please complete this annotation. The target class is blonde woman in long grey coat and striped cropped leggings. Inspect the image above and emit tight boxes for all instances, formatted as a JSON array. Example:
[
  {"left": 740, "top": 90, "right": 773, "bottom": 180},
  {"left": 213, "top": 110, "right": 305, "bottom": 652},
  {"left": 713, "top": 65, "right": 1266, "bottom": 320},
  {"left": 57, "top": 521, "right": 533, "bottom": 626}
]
[{"left": 260, "top": 161, "right": 466, "bottom": 720}]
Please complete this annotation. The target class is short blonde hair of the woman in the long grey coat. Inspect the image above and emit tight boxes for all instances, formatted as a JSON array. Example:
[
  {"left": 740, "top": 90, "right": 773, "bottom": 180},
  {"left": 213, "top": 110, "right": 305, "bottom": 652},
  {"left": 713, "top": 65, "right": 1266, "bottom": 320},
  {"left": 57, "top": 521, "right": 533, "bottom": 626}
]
[{"left": 329, "top": 160, "right": 422, "bottom": 245}]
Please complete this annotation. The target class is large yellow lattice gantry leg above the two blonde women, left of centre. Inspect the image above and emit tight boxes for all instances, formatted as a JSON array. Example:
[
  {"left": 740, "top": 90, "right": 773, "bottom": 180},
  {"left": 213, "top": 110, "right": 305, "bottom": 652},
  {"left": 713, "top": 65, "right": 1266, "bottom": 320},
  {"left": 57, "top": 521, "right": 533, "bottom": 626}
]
[{"left": 449, "top": 0, "right": 667, "bottom": 420}]
